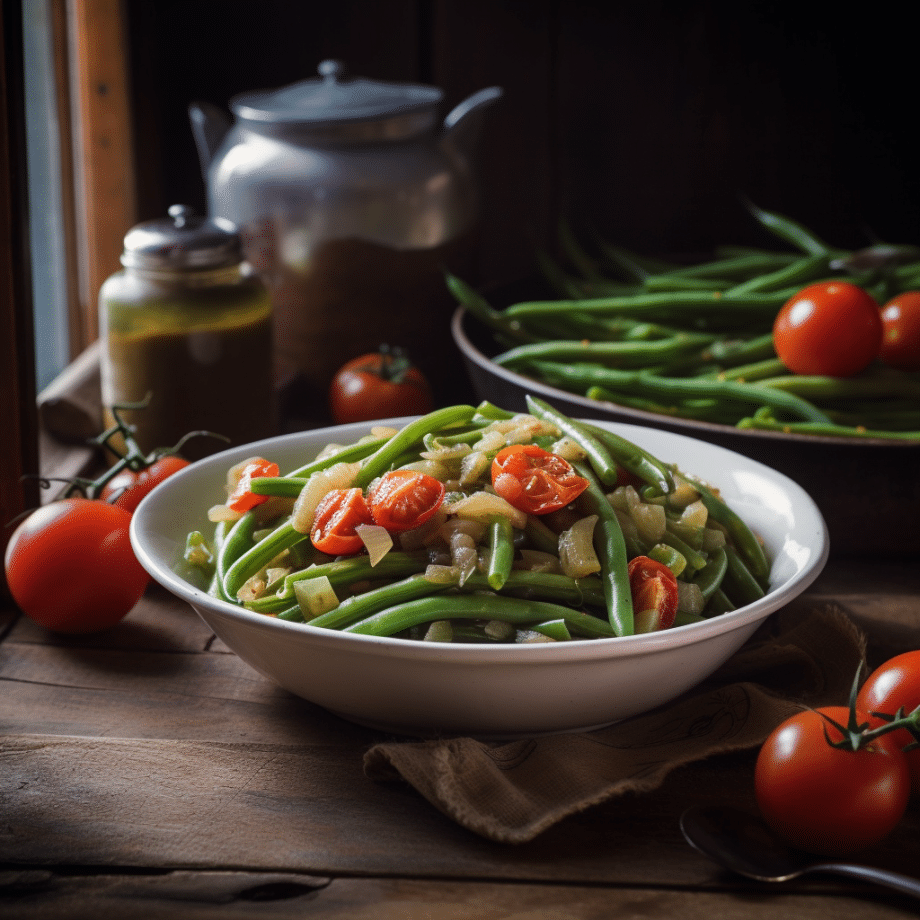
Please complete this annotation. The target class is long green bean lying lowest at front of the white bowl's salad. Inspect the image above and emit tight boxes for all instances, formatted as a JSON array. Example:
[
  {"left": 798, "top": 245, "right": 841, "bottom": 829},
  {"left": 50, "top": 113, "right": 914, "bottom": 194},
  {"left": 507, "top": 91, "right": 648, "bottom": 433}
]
[{"left": 343, "top": 594, "right": 603, "bottom": 636}]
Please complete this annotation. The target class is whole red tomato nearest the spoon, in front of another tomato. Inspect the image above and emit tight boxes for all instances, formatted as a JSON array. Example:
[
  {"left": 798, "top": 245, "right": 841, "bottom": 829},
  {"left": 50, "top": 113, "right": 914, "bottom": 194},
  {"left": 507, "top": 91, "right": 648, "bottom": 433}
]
[{"left": 754, "top": 706, "right": 910, "bottom": 856}]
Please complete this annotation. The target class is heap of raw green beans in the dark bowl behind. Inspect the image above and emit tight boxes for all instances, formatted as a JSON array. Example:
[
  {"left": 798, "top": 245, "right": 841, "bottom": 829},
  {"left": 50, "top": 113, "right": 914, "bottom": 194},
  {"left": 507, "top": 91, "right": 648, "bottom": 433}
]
[{"left": 447, "top": 205, "right": 920, "bottom": 441}]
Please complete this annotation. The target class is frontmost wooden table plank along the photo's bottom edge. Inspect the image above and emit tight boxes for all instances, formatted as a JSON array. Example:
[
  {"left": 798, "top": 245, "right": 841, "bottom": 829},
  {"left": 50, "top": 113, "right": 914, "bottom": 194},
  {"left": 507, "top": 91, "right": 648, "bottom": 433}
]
[{"left": 0, "top": 871, "right": 913, "bottom": 920}]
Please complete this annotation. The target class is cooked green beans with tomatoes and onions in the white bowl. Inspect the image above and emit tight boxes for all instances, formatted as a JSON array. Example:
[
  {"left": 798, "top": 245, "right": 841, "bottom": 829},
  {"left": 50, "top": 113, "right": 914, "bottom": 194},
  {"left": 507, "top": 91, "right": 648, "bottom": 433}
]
[{"left": 184, "top": 397, "right": 769, "bottom": 643}]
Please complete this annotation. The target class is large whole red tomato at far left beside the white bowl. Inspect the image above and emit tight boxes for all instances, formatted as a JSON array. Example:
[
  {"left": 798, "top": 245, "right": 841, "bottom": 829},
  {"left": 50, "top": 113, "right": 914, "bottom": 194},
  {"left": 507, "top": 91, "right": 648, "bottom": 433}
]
[{"left": 5, "top": 498, "right": 150, "bottom": 633}]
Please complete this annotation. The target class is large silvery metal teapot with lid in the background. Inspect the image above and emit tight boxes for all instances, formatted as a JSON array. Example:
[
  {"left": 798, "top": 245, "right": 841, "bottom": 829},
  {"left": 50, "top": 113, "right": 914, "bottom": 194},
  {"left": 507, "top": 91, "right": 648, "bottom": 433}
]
[{"left": 189, "top": 60, "right": 502, "bottom": 400}]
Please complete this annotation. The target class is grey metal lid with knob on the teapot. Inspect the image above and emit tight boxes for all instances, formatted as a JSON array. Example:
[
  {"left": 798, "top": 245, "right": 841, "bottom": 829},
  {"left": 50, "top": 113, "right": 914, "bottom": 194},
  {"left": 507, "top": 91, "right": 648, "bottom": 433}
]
[{"left": 230, "top": 60, "right": 444, "bottom": 126}]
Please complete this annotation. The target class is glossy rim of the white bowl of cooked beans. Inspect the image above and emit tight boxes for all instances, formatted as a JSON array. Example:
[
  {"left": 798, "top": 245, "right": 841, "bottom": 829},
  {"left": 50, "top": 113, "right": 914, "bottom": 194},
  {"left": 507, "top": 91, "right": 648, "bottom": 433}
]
[{"left": 130, "top": 416, "right": 830, "bottom": 664}]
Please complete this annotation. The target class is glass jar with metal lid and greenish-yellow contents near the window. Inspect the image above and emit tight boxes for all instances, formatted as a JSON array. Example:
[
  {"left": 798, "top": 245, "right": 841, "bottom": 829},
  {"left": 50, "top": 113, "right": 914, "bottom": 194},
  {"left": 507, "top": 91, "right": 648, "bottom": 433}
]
[{"left": 99, "top": 205, "right": 276, "bottom": 460}]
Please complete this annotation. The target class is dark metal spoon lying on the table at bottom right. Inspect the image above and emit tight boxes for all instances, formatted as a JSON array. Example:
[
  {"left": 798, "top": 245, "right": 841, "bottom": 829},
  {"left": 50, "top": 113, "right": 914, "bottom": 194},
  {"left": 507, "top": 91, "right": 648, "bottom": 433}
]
[{"left": 680, "top": 806, "right": 920, "bottom": 898}]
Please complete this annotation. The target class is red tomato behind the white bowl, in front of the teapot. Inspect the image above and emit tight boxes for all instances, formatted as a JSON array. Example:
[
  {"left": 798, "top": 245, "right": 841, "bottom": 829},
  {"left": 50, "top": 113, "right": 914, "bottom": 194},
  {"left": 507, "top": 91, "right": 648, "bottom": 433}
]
[{"left": 329, "top": 346, "right": 434, "bottom": 425}]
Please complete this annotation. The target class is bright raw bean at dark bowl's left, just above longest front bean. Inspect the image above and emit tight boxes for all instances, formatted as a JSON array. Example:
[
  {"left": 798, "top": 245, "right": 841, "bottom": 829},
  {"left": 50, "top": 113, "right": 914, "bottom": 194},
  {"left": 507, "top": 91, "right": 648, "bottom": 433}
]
[{"left": 493, "top": 332, "right": 715, "bottom": 368}]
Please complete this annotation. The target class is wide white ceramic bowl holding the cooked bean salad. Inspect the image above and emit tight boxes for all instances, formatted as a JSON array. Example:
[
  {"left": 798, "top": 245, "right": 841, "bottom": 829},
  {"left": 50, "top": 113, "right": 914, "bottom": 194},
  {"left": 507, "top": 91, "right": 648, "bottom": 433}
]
[{"left": 131, "top": 419, "right": 828, "bottom": 737}]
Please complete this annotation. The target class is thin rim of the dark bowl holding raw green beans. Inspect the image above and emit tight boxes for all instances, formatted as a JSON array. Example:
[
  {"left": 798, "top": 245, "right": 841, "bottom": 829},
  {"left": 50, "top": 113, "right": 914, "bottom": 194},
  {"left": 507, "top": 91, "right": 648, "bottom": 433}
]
[{"left": 450, "top": 304, "right": 920, "bottom": 451}]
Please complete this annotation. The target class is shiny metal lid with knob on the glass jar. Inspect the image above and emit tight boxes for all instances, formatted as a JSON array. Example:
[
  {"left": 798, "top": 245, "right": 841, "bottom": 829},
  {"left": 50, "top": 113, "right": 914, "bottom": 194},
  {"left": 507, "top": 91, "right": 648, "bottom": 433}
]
[{"left": 121, "top": 204, "right": 243, "bottom": 271}]
